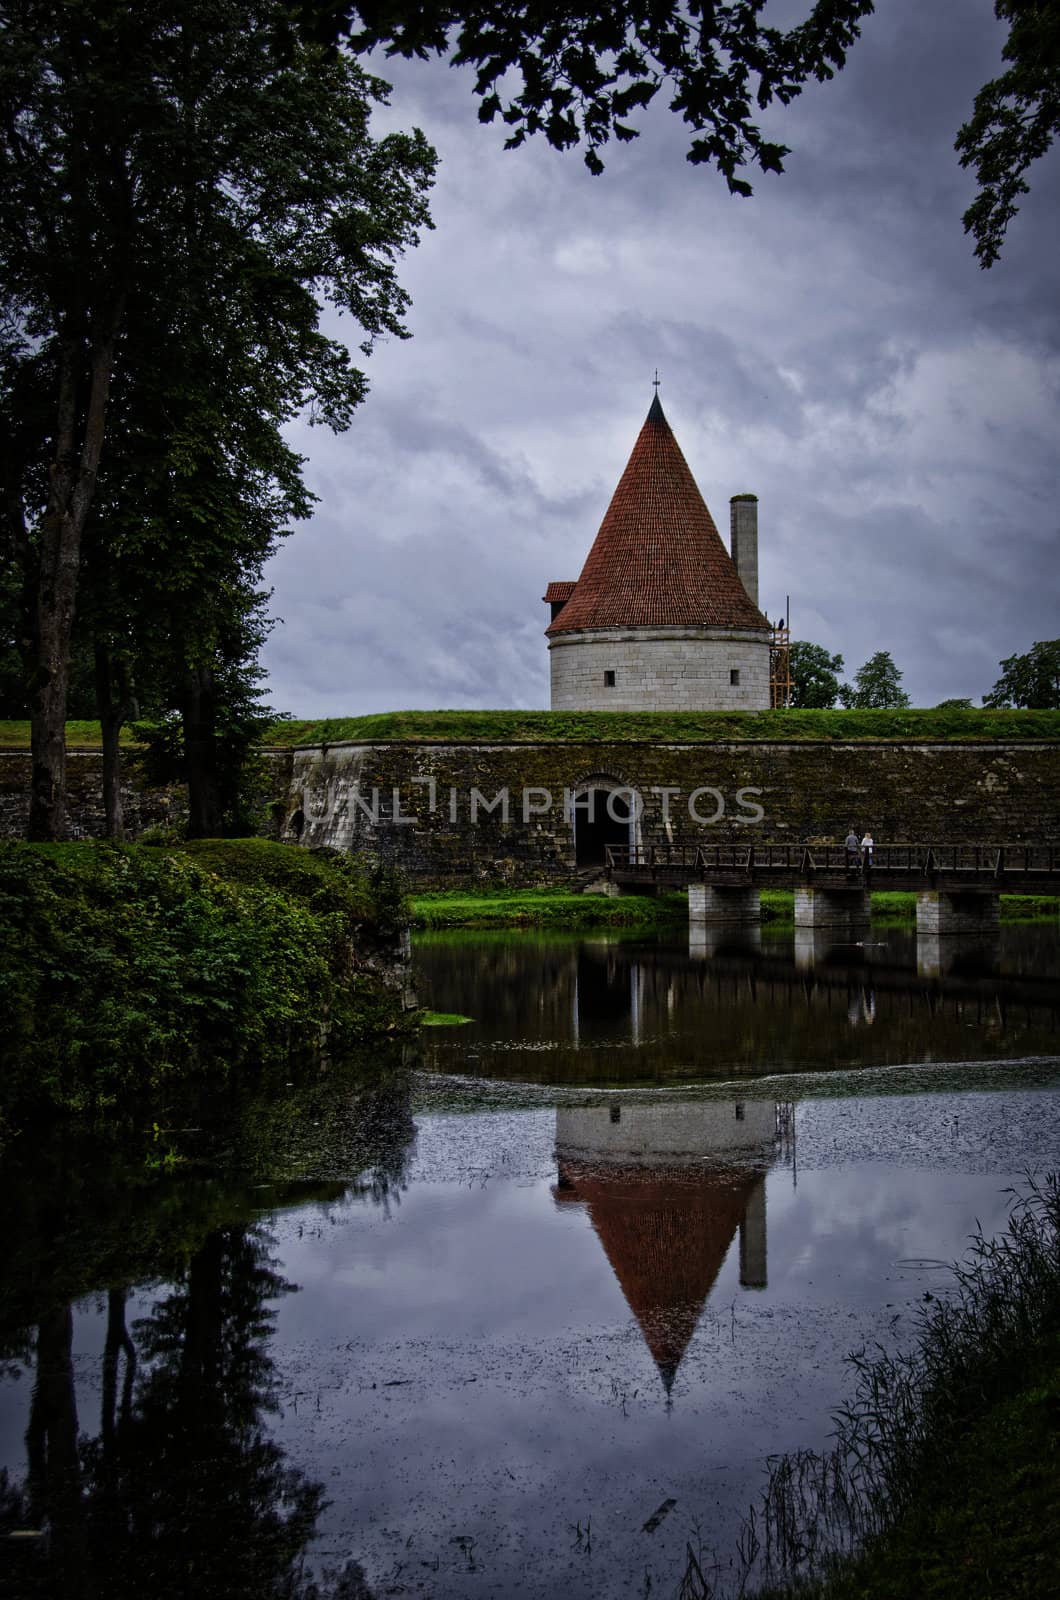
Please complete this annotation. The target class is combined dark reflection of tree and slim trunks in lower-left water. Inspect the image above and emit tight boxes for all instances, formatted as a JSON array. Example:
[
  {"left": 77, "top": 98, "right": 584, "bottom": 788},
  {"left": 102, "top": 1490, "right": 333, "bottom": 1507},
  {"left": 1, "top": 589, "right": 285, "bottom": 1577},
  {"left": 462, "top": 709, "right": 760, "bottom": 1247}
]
[{"left": 0, "top": 1226, "right": 382, "bottom": 1600}]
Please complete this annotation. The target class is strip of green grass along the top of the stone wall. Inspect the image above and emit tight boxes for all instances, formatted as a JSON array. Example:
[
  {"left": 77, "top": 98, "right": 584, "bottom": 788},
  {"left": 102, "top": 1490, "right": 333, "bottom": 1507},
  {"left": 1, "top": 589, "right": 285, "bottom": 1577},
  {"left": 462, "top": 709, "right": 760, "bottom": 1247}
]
[{"left": 0, "top": 709, "right": 1060, "bottom": 750}]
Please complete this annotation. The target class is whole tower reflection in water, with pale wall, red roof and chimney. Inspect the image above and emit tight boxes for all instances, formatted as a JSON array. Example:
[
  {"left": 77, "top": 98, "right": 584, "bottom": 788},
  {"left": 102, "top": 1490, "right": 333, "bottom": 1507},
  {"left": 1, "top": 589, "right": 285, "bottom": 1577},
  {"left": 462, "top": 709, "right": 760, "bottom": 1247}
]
[{"left": 552, "top": 1099, "right": 783, "bottom": 1395}]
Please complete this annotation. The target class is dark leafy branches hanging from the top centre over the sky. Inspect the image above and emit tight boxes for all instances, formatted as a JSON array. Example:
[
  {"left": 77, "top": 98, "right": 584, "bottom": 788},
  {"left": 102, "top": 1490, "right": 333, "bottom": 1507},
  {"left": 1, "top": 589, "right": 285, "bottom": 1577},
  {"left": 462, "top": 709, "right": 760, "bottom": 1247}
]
[{"left": 352, "top": 0, "right": 873, "bottom": 195}]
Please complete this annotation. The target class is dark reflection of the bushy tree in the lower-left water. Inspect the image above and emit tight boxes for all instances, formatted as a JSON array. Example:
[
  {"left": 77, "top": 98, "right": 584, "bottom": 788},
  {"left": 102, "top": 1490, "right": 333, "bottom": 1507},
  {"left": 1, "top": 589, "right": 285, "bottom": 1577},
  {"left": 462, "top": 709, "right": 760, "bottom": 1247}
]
[{"left": 96, "top": 1227, "right": 322, "bottom": 1597}]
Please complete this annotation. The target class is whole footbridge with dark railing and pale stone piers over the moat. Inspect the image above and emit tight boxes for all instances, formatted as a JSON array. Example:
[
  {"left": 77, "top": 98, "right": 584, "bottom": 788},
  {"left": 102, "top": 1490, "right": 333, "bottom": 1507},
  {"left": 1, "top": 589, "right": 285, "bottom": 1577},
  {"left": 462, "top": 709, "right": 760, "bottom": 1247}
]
[{"left": 607, "top": 843, "right": 1060, "bottom": 934}]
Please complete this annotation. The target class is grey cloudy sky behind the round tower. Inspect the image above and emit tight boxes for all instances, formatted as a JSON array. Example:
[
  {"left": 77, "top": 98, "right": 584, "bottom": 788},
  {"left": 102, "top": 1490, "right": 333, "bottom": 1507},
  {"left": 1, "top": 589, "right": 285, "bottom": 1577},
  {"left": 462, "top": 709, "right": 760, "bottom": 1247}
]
[{"left": 264, "top": 0, "right": 1060, "bottom": 717}]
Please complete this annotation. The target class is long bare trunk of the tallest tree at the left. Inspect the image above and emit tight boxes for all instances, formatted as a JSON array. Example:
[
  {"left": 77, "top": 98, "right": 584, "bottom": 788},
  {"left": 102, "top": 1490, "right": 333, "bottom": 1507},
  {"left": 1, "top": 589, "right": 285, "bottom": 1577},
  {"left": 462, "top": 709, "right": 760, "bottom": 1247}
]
[{"left": 29, "top": 318, "right": 122, "bottom": 840}]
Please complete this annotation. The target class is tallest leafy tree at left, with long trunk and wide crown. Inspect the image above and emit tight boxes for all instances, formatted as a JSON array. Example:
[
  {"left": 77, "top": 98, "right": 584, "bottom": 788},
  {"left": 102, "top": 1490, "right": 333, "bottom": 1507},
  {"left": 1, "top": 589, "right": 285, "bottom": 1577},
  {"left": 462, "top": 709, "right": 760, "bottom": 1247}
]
[{"left": 0, "top": 0, "right": 434, "bottom": 838}]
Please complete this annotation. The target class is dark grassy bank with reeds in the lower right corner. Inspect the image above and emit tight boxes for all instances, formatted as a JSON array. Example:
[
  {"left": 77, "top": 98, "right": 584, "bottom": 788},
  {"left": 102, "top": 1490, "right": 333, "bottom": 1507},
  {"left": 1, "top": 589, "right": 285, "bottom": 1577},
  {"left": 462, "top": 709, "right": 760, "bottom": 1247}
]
[{"left": 742, "top": 1174, "right": 1060, "bottom": 1600}]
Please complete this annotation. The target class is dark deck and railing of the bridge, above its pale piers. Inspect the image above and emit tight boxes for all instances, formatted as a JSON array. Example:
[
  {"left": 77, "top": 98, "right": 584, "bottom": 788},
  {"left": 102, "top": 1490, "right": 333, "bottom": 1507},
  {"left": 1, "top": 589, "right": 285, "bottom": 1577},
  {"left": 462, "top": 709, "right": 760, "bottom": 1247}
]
[{"left": 607, "top": 843, "right": 1060, "bottom": 894}]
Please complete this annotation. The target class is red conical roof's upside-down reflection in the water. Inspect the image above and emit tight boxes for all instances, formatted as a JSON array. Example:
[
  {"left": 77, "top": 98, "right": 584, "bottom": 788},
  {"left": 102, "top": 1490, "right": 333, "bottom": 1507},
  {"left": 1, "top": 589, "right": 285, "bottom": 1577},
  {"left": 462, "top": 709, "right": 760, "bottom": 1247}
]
[{"left": 552, "top": 1158, "right": 762, "bottom": 1394}]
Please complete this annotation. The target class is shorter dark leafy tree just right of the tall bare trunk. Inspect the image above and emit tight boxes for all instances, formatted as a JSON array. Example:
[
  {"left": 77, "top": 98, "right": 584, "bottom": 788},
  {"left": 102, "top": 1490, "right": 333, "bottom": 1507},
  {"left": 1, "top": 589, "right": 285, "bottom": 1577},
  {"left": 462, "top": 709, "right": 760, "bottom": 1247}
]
[{"left": 82, "top": 265, "right": 320, "bottom": 837}]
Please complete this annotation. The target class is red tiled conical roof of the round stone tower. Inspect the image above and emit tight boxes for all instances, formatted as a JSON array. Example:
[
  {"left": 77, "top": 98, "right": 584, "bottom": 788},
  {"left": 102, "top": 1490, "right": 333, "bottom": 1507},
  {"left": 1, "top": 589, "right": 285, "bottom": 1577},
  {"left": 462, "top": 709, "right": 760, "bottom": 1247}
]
[{"left": 546, "top": 395, "right": 769, "bottom": 634}]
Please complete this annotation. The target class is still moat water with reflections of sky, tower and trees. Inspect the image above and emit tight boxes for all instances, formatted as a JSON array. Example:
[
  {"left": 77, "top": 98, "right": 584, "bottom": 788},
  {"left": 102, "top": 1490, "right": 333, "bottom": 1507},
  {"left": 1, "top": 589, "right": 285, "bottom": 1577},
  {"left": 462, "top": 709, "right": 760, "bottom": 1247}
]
[{"left": 0, "top": 925, "right": 1060, "bottom": 1600}]
